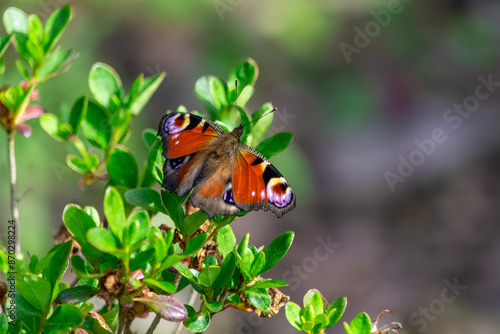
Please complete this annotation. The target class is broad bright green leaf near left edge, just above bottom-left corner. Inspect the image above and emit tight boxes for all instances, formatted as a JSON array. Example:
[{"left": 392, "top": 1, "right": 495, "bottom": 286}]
[{"left": 16, "top": 275, "right": 52, "bottom": 314}]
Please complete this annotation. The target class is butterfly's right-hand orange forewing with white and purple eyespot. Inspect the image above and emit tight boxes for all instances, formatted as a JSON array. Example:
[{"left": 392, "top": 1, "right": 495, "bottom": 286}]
[{"left": 232, "top": 144, "right": 295, "bottom": 217}]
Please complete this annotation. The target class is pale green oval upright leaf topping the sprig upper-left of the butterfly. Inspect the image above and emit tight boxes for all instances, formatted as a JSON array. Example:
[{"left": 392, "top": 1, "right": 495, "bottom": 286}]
[{"left": 89, "top": 63, "right": 123, "bottom": 109}]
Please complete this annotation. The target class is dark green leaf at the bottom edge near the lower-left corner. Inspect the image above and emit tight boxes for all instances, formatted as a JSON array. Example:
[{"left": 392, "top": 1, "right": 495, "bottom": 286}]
[{"left": 44, "top": 304, "right": 83, "bottom": 334}]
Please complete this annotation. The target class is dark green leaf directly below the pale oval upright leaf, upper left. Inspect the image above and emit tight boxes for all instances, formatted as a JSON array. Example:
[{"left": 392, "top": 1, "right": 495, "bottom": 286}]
[{"left": 82, "top": 100, "right": 111, "bottom": 149}]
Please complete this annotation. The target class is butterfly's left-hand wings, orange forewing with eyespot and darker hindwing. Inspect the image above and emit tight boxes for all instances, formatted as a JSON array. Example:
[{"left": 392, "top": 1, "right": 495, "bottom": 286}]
[{"left": 158, "top": 113, "right": 225, "bottom": 196}]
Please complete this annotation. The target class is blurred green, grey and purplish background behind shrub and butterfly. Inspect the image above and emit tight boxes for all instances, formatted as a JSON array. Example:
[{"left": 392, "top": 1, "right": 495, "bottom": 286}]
[{"left": 0, "top": 0, "right": 500, "bottom": 333}]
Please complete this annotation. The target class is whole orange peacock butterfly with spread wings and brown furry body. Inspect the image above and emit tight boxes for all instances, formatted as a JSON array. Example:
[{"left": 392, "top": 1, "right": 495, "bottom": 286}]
[{"left": 158, "top": 112, "right": 295, "bottom": 218}]
